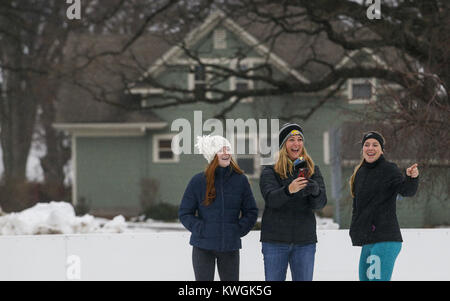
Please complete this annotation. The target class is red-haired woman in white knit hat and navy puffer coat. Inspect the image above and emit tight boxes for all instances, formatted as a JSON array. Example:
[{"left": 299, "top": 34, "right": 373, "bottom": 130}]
[{"left": 179, "top": 136, "right": 258, "bottom": 281}]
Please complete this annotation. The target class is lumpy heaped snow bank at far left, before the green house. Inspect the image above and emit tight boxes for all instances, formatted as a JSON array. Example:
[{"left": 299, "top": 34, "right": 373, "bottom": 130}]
[{"left": 0, "top": 202, "right": 127, "bottom": 235}]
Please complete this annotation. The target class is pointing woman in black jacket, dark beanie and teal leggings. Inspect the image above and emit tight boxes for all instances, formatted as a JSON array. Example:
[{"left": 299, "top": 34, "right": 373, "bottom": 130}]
[{"left": 350, "top": 131, "right": 419, "bottom": 281}]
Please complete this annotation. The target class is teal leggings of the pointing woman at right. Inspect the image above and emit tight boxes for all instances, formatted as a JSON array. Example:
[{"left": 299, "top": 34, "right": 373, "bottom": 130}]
[{"left": 359, "top": 241, "right": 402, "bottom": 281}]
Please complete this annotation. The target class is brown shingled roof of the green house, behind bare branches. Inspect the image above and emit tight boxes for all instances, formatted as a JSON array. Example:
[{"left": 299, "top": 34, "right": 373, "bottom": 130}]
[{"left": 56, "top": 12, "right": 394, "bottom": 123}]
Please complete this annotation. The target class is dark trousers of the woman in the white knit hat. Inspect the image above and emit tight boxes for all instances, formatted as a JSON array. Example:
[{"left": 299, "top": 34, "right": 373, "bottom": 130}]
[{"left": 192, "top": 247, "right": 239, "bottom": 281}]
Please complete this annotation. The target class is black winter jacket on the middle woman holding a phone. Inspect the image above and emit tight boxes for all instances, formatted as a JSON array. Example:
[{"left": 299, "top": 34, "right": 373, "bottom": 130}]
[{"left": 259, "top": 166, "right": 327, "bottom": 244}]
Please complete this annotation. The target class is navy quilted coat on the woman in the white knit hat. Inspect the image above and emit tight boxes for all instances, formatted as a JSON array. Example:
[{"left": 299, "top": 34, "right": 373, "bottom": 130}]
[{"left": 178, "top": 166, "right": 258, "bottom": 252}]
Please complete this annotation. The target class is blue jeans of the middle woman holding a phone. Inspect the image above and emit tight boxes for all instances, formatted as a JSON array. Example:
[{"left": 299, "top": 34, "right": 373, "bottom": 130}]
[{"left": 262, "top": 242, "right": 316, "bottom": 281}]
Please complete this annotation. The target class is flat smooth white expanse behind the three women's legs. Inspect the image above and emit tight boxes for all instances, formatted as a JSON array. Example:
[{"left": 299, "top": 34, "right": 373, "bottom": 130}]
[{"left": 0, "top": 229, "right": 450, "bottom": 281}]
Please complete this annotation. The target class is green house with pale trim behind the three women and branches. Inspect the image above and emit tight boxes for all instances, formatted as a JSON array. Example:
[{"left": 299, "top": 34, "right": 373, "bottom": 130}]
[{"left": 54, "top": 12, "right": 450, "bottom": 227}]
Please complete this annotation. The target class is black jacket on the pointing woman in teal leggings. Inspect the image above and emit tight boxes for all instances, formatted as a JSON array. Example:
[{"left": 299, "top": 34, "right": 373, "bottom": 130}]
[{"left": 350, "top": 155, "right": 419, "bottom": 246}]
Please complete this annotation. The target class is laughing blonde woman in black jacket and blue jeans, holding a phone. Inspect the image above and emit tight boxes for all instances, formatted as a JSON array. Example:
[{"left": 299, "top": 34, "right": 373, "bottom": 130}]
[{"left": 259, "top": 123, "right": 327, "bottom": 281}]
